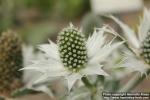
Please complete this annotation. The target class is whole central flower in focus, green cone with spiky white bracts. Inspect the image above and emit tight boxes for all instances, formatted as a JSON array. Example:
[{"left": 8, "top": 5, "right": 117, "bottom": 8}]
[{"left": 21, "top": 25, "right": 123, "bottom": 90}]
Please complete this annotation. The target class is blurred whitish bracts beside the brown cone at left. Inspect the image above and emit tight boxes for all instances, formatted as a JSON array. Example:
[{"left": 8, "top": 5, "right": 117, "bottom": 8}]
[{"left": 23, "top": 45, "right": 53, "bottom": 97}]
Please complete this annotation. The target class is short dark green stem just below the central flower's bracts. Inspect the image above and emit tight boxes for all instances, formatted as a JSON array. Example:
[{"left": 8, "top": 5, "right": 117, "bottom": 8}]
[{"left": 82, "top": 77, "right": 97, "bottom": 100}]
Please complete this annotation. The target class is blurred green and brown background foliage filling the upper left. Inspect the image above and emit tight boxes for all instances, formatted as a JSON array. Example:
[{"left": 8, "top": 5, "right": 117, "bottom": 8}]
[{"left": 0, "top": 0, "right": 90, "bottom": 45}]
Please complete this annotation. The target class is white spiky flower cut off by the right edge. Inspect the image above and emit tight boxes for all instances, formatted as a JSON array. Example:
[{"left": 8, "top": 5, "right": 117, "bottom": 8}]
[{"left": 111, "top": 8, "right": 150, "bottom": 74}]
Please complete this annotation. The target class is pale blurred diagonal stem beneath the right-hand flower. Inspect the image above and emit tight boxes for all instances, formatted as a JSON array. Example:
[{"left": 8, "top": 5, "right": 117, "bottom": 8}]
[{"left": 119, "top": 69, "right": 150, "bottom": 92}]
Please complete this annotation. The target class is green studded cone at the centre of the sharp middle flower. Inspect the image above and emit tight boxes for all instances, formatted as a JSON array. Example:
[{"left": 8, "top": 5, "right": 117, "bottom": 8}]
[{"left": 58, "top": 26, "right": 87, "bottom": 72}]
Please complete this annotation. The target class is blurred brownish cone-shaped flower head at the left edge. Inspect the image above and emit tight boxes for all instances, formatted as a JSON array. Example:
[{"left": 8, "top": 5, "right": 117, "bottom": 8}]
[{"left": 0, "top": 31, "right": 23, "bottom": 96}]
